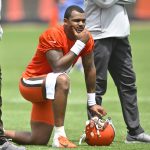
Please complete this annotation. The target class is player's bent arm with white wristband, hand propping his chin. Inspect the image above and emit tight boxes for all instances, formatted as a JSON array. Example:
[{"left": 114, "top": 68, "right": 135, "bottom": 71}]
[{"left": 46, "top": 28, "right": 89, "bottom": 72}]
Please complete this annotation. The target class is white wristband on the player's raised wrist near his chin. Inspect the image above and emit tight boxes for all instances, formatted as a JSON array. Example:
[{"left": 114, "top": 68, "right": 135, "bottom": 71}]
[{"left": 71, "top": 40, "right": 85, "bottom": 55}]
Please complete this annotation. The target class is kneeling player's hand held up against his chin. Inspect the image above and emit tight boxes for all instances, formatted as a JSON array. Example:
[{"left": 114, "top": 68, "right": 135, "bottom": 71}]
[{"left": 73, "top": 28, "right": 90, "bottom": 44}]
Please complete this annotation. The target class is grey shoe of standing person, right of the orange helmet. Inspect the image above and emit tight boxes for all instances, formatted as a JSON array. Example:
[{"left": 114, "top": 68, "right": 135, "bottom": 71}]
[{"left": 125, "top": 132, "right": 150, "bottom": 143}]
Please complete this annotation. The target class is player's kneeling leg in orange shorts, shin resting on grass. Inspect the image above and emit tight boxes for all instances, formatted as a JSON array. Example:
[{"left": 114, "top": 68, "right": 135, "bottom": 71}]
[{"left": 5, "top": 77, "right": 54, "bottom": 145}]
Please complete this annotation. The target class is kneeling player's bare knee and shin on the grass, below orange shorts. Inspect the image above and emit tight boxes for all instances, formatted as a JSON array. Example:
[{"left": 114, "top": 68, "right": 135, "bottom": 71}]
[{"left": 5, "top": 121, "right": 53, "bottom": 145}]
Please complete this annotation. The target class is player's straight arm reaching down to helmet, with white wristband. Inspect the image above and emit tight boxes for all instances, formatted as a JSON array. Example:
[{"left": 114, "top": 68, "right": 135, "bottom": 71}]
[{"left": 82, "top": 53, "right": 106, "bottom": 116}]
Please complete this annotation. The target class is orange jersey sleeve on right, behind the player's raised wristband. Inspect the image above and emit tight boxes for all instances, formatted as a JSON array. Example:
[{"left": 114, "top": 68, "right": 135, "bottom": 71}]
[{"left": 81, "top": 33, "right": 94, "bottom": 57}]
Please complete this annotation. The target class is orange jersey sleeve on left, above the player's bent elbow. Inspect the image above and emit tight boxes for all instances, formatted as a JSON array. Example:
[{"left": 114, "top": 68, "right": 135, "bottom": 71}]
[{"left": 37, "top": 29, "right": 62, "bottom": 53}]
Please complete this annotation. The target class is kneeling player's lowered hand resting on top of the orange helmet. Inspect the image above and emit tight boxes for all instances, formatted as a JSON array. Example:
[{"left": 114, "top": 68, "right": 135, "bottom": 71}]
[{"left": 90, "top": 104, "right": 107, "bottom": 117}]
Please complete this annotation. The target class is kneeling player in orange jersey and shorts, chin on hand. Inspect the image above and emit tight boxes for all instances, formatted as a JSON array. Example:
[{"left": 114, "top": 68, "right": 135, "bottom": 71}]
[{"left": 5, "top": 5, "right": 106, "bottom": 148}]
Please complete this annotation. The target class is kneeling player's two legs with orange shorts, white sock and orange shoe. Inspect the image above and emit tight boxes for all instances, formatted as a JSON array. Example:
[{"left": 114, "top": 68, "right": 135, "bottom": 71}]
[{"left": 5, "top": 74, "right": 75, "bottom": 148}]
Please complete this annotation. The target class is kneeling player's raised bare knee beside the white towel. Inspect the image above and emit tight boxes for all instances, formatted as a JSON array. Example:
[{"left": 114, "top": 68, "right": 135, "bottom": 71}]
[{"left": 57, "top": 73, "right": 70, "bottom": 91}]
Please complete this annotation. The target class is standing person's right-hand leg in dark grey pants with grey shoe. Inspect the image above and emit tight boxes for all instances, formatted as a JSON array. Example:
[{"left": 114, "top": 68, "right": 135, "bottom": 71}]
[{"left": 109, "top": 38, "right": 150, "bottom": 142}]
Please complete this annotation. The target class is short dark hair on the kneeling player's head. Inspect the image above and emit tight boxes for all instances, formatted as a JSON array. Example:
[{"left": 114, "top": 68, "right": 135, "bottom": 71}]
[{"left": 64, "top": 5, "right": 84, "bottom": 19}]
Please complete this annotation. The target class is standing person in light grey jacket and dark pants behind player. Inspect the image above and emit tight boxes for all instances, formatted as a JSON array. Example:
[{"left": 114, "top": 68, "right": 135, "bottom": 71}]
[{"left": 85, "top": 0, "right": 150, "bottom": 143}]
